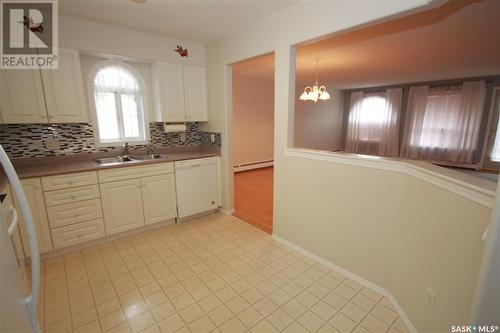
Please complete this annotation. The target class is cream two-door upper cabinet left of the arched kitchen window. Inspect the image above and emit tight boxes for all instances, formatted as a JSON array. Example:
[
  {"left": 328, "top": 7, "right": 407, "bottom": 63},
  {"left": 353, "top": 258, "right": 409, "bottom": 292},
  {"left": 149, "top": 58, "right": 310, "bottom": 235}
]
[{"left": 0, "top": 49, "right": 88, "bottom": 124}]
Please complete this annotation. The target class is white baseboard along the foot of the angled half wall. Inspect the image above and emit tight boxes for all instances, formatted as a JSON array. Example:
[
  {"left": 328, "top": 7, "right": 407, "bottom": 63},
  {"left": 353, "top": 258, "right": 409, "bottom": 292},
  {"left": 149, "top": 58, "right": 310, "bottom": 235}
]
[{"left": 272, "top": 234, "right": 418, "bottom": 333}]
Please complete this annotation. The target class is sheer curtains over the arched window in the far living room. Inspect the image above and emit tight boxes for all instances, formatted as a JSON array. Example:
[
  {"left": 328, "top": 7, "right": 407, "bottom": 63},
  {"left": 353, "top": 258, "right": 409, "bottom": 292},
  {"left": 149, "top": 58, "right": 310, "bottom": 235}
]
[{"left": 346, "top": 88, "right": 403, "bottom": 156}]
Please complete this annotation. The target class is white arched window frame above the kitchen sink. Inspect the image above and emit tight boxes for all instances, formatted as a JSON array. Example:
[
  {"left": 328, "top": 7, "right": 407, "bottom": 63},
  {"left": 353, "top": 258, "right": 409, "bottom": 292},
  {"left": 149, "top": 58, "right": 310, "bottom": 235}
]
[{"left": 88, "top": 59, "right": 150, "bottom": 147}]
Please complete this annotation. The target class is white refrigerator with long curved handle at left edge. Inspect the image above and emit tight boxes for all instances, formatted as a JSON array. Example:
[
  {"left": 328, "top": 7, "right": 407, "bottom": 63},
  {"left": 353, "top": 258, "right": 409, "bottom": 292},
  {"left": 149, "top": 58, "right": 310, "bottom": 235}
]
[{"left": 0, "top": 145, "right": 40, "bottom": 333}]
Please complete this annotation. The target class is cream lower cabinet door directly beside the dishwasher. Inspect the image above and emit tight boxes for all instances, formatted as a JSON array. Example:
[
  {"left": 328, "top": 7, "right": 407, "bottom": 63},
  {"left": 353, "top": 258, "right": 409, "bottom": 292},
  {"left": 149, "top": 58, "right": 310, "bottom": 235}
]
[{"left": 141, "top": 174, "right": 177, "bottom": 224}]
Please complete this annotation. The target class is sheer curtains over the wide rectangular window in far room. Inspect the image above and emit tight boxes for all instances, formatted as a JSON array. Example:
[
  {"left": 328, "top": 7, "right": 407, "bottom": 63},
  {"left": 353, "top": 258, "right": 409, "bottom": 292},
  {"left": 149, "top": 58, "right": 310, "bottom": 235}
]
[{"left": 401, "top": 81, "right": 486, "bottom": 163}]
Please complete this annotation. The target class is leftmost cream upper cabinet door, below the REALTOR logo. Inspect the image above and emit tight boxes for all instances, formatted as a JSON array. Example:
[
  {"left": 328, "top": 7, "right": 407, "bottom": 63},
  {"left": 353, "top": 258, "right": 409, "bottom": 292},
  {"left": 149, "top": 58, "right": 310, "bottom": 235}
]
[{"left": 0, "top": 69, "right": 47, "bottom": 124}]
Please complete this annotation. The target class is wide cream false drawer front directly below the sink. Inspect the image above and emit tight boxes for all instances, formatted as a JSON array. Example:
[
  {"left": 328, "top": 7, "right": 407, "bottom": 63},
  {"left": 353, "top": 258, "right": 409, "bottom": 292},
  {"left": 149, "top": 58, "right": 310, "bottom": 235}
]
[{"left": 98, "top": 162, "right": 174, "bottom": 183}]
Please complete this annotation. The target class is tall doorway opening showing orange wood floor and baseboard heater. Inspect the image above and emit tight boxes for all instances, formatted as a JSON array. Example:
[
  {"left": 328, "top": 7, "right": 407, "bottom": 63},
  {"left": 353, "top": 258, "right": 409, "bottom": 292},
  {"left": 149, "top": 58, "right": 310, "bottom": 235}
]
[{"left": 232, "top": 53, "right": 274, "bottom": 233}]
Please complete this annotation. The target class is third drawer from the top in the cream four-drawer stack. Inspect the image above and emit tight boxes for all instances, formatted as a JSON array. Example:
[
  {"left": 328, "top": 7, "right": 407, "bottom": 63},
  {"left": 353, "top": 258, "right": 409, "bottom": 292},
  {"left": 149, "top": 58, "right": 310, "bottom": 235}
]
[{"left": 47, "top": 199, "right": 102, "bottom": 228}]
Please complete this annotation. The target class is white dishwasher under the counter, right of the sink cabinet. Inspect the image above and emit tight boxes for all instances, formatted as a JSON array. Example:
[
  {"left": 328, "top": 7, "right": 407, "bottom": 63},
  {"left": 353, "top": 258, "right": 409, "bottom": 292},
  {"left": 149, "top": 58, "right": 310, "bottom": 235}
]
[{"left": 175, "top": 157, "right": 219, "bottom": 218}]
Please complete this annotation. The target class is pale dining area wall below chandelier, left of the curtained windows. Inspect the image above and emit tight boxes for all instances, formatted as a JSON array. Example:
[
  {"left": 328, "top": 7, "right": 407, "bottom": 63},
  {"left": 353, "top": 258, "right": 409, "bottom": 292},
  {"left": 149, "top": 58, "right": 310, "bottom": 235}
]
[{"left": 293, "top": 84, "right": 344, "bottom": 151}]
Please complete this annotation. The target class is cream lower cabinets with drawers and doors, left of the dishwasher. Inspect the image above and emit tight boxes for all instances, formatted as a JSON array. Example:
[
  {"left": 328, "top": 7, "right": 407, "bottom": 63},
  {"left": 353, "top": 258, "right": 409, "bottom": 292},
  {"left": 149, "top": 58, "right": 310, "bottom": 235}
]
[{"left": 19, "top": 162, "right": 201, "bottom": 253}]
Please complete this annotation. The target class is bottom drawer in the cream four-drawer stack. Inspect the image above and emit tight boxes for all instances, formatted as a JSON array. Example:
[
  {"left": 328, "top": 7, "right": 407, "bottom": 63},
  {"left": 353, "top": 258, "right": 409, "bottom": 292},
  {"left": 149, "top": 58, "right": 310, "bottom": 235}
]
[{"left": 50, "top": 219, "right": 106, "bottom": 249}]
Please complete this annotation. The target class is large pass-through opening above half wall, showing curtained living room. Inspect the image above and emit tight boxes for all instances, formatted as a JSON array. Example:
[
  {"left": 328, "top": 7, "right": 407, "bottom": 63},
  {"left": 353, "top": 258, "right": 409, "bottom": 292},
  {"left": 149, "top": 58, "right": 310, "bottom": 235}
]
[{"left": 292, "top": 1, "right": 500, "bottom": 176}]
